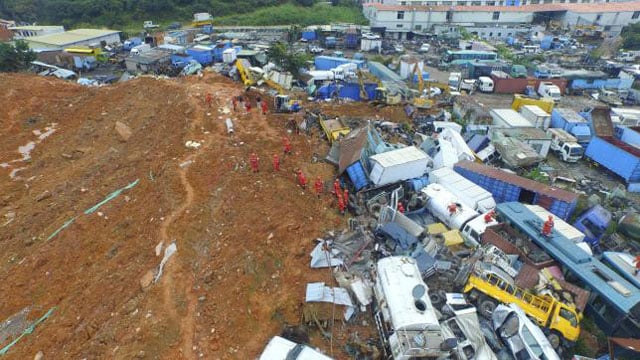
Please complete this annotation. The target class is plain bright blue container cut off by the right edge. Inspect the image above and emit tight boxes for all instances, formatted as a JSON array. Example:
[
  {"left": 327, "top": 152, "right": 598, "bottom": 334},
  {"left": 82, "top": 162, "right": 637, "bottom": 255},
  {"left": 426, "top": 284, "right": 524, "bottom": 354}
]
[{"left": 585, "top": 136, "right": 640, "bottom": 184}]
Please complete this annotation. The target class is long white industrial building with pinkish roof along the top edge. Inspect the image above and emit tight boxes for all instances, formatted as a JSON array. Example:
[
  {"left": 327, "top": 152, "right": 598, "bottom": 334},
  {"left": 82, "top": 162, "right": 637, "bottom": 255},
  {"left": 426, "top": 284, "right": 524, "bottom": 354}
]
[{"left": 363, "top": 0, "right": 640, "bottom": 39}]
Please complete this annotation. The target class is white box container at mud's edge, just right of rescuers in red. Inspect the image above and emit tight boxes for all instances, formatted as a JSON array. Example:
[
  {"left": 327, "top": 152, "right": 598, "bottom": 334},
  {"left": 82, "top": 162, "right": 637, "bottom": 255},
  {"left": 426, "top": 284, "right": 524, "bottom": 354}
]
[{"left": 369, "top": 146, "right": 432, "bottom": 185}]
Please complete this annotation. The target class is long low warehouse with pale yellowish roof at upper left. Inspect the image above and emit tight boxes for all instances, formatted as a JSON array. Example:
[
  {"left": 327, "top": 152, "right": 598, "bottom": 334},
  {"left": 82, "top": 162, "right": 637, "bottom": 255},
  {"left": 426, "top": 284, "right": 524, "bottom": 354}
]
[{"left": 25, "top": 29, "right": 120, "bottom": 52}]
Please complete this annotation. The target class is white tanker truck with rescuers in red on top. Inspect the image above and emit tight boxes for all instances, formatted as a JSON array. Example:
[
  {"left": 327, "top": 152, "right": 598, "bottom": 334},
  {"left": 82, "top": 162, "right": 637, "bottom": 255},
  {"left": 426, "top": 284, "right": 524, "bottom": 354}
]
[{"left": 422, "top": 184, "right": 498, "bottom": 246}]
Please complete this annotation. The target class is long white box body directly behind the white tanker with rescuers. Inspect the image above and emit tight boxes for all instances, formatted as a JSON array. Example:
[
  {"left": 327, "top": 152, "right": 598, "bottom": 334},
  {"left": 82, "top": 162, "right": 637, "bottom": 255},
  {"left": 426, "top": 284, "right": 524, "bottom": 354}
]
[{"left": 429, "top": 167, "right": 496, "bottom": 213}]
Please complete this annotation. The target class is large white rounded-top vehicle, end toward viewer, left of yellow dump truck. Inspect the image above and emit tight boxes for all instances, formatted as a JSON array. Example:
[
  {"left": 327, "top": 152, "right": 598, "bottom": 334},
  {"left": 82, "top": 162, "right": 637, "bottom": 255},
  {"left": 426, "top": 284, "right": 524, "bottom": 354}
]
[{"left": 373, "top": 256, "right": 448, "bottom": 360}]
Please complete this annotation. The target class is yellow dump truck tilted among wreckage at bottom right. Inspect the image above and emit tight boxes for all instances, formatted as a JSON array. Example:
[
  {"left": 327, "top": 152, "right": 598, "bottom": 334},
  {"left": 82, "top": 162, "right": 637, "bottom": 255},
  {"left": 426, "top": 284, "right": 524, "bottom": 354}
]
[{"left": 464, "top": 273, "right": 582, "bottom": 347}]
